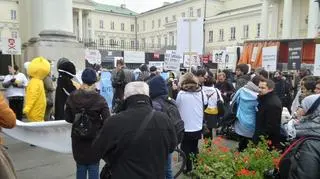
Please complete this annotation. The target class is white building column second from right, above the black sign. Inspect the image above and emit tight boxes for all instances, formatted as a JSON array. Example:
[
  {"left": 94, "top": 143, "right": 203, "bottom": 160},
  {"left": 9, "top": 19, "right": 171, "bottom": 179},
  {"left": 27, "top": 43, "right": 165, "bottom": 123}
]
[{"left": 282, "top": 0, "right": 293, "bottom": 39}]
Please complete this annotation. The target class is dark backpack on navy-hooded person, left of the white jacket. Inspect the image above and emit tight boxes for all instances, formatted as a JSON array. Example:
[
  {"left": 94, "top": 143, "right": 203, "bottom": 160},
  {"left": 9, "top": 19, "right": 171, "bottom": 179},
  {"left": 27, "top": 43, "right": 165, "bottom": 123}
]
[{"left": 159, "top": 97, "right": 184, "bottom": 144}]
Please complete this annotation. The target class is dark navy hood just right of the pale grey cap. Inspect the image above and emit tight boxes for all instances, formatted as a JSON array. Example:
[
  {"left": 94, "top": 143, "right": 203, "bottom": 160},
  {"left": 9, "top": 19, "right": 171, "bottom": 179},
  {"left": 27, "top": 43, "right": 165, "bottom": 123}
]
[{"left": 148, "top": 76, "right": 168, "bottom": 99}]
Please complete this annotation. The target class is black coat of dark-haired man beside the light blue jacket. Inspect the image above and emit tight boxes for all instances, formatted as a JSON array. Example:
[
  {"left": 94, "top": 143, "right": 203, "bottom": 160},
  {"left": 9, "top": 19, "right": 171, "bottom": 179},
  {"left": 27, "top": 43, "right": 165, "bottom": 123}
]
[{"left": 253, "top": 91, "right": 282, "bottom": 148}]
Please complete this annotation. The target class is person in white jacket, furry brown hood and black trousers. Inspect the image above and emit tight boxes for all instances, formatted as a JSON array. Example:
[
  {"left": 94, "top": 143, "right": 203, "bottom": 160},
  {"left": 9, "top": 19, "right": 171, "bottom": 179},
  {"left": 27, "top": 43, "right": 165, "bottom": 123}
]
[{"left": 176, "top": 73, "right": 208, "bottom": 174}]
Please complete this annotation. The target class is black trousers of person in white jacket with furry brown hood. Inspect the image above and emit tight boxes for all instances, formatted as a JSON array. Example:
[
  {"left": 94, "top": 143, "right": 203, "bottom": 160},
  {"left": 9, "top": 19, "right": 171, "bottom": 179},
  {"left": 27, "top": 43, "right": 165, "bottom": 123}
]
[{"left": 181, "top": 131, "right": 201, "bottom": 172}]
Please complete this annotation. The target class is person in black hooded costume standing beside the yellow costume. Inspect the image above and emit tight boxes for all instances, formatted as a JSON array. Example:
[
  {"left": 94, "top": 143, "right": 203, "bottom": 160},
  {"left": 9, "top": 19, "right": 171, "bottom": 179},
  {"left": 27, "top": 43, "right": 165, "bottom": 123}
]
[{"left": 54, "top": 58, "right": 77, "bottom": 120}]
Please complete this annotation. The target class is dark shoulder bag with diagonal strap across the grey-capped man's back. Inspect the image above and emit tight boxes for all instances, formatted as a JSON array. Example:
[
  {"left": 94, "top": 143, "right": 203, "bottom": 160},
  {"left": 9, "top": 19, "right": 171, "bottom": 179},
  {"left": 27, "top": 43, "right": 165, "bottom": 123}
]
[{"left": 100, "top": 110, "right": 154, "bottom": 179}]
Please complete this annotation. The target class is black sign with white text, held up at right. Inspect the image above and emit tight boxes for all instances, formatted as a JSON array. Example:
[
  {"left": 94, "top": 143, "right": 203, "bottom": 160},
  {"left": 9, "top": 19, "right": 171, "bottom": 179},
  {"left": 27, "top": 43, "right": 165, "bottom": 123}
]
[{"left": 288, "top": 41, "right": 302, "bottom": 70}]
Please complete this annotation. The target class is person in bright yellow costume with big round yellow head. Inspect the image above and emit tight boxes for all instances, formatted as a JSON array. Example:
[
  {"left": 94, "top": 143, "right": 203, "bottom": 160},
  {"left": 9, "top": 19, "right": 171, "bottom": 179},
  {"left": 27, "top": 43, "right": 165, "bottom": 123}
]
[{"left": 23, "top": 57, "right": 50, "bottom": 122}]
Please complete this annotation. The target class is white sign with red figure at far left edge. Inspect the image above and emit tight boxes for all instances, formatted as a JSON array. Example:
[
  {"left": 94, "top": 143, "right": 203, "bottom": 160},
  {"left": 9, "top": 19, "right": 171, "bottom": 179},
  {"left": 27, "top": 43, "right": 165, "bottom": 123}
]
[{"left": 1, "top": 38, "right": 21, "bottom": 55}]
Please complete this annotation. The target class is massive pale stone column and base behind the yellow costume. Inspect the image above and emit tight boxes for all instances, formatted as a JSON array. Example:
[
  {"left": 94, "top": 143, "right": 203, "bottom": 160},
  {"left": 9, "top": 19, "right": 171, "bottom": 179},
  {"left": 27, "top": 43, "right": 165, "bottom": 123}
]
[{"left": 22, "top": 0, "right": 85, "bottom": 75}]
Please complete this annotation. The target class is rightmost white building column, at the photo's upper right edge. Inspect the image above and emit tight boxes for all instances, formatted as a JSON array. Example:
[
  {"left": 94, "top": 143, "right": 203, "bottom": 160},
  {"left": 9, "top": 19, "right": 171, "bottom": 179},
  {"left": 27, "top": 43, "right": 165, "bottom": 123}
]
[{"left": 308, "top": 0, "right": 319, "bottom": 38}]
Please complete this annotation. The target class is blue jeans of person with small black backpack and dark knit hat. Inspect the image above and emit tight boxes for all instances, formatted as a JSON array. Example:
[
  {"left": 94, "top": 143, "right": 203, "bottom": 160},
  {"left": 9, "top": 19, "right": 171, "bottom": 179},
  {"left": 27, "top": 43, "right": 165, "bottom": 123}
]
[{"left": 76, "top": 162, "right": 99, "bottom": 179}]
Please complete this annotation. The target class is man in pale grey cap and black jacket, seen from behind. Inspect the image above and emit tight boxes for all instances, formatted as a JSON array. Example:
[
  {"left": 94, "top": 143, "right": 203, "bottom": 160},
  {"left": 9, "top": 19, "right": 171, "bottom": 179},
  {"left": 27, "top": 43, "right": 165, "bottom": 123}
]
[{"left": 93, "top": 82, "right": 177, "bottom": 179}]
